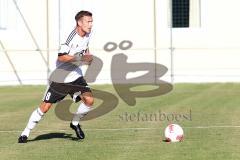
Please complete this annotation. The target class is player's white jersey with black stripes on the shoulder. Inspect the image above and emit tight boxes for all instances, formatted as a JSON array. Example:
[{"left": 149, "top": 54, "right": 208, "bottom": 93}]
[{"left": 50, "top": 29, "right": 91, "bottom": 83}]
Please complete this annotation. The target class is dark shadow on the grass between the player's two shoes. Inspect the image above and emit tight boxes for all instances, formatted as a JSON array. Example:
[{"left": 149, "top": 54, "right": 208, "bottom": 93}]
[{"left": 28, "top": 133, "right": 82, "bottom": 142}]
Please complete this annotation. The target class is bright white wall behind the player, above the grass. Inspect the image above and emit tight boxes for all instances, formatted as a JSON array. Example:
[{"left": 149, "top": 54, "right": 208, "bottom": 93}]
[{"left": 0, "top": 0, "right": 240, "bottom": 85}]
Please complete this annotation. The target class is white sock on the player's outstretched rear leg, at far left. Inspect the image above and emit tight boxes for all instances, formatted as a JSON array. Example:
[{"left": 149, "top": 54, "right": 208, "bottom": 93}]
[{"left": 21, "top": 108, "right": 44, "bottom": 137}]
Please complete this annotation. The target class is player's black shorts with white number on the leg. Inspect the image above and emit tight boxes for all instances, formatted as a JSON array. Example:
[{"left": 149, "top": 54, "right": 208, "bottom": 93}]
[{"left": 43, "top": 77, "right": 91, "bottom": 103}]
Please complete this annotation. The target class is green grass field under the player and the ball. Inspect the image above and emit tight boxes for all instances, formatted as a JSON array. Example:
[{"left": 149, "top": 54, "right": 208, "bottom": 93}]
[{"left": 0, "top": 83, "right": 240, "bottom": 160}]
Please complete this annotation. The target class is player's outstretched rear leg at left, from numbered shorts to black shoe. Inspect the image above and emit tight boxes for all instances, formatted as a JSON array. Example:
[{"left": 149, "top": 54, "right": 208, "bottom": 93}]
[{"left": 18, "top": 82, "right": 66, "bottom": 143}]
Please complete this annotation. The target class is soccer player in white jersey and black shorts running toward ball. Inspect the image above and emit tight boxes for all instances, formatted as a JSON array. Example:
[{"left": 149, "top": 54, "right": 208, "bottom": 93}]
[{"left": 18, "top": 11, "right": 94, "bottom": 143}]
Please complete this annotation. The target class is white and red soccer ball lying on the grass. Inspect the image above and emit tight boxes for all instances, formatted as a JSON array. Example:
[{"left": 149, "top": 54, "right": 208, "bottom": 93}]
[{"left": 164, "top": 124, "right": 183, "bottom": 142}]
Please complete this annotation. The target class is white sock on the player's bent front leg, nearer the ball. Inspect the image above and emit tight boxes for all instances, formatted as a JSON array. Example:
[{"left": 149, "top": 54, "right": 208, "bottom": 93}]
[{"left": 72, "top": 103, "right": 92, "bottom": 126}]
